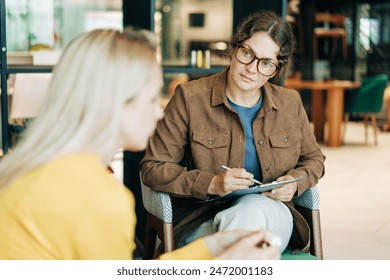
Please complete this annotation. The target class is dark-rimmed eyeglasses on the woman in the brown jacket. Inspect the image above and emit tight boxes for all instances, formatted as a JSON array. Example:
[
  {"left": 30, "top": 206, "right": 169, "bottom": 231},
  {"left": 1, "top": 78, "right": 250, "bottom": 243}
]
[{"left": 236, "top": 45, "right": 280, "bottom": 77}]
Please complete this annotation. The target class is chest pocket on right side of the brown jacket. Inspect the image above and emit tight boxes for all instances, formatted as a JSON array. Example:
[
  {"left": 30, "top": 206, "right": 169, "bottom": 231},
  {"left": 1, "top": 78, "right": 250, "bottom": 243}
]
[{"left": 269, "top": 129, "right": 302, "bottom": 172}]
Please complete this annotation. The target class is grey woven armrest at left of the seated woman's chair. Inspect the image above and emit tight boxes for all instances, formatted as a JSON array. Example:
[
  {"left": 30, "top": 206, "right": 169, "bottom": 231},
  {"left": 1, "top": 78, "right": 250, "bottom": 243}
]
[{"left": 141, "top": 180, "right": 172, "bottom": 224}]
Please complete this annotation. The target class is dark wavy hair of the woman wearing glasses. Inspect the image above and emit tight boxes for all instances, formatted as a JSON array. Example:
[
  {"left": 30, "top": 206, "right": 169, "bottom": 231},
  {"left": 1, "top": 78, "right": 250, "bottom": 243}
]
[{"left": 227, "top": 11, "right": 295, "bottom": 81}]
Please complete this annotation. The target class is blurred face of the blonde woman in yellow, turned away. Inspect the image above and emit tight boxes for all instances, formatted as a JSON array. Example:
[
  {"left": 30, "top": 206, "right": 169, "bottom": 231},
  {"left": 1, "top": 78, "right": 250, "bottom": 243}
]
[{"left": 121, "top": 64, "right": 163, "bottom": 152}]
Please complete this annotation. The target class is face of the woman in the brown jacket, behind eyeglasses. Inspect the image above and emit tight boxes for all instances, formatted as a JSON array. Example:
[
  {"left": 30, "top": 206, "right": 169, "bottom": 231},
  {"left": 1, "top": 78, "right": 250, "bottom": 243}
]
[{"left": 229, "top": 32, "right": 280, "bottom": 92}]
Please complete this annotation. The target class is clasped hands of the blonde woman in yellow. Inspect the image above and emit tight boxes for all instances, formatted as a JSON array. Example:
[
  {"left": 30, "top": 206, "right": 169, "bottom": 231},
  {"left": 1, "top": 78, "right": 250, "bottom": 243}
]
[{"left": 204, "top": 230, "right": 280, "bottom": 260}]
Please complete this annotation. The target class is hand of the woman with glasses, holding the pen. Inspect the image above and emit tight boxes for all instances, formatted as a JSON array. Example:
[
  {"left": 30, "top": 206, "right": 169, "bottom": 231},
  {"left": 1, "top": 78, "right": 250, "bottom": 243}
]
[{"left": 207, "top": 168, "right": 253, "bottom": 195}]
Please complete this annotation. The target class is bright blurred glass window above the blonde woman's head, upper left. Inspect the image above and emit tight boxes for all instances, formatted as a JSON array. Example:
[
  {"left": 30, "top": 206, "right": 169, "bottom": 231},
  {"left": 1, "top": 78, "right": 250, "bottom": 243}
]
[{"left": 6, "top": 0, "right": 122, "bottom": 65}]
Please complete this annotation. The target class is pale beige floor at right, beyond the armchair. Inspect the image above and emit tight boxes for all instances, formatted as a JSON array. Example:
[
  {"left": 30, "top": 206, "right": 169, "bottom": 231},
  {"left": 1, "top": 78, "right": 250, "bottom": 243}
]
[{"left": 318, "top": 123, "right": 390, "bottom": 260}]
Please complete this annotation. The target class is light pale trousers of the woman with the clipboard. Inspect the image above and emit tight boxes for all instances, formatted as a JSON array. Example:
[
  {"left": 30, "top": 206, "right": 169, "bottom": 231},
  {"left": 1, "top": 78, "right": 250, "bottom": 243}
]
[{"left": 179, "top": 194, "right": 293, "bottom": 252}]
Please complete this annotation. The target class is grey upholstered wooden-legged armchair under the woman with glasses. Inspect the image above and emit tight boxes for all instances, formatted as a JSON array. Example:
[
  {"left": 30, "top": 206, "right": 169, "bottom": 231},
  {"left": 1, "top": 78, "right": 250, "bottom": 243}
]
[{"left": 141, "top": 180, "right": 323, "bottom": 259}]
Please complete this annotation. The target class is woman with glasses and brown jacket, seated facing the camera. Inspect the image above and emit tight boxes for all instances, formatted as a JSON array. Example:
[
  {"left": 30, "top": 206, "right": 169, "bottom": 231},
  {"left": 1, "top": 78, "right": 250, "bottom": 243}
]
[{"left": 141, "top": 12, "right": 325, "bottom": 252}]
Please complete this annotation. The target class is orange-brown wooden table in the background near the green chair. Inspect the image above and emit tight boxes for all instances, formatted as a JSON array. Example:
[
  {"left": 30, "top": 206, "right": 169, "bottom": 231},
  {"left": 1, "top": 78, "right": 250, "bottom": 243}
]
[{"left": 284, "top": 79, "right": 360, "bottom": 147}]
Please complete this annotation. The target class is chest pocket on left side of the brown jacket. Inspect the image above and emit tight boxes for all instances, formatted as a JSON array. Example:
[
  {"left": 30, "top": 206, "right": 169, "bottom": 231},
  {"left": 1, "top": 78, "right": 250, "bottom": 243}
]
[{"left": 191, "top": 130, "right": 231, "bottom": 173}]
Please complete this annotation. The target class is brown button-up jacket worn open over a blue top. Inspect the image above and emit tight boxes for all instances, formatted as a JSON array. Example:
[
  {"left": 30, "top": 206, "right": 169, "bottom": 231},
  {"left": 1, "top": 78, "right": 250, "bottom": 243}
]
[{"left": 141, "top": 68, "right": 325, "bottom": 252}]
